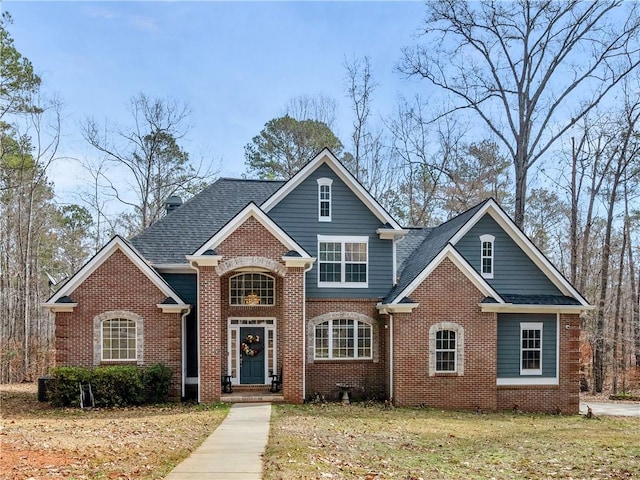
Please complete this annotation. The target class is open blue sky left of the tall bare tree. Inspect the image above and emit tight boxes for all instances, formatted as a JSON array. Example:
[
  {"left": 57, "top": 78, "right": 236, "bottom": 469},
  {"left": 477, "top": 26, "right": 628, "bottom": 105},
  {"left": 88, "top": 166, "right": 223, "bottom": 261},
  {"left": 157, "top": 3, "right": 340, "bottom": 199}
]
[{"left": 2, "top": 0, "right": 424, "bottom": 201}]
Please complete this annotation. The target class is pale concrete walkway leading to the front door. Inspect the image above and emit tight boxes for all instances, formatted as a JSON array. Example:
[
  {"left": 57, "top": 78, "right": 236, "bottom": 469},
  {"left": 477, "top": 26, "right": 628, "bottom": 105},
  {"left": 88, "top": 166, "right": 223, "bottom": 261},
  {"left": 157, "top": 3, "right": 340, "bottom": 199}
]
[{"left": 165, "top": 403, "right": 271, "bottom": 480}]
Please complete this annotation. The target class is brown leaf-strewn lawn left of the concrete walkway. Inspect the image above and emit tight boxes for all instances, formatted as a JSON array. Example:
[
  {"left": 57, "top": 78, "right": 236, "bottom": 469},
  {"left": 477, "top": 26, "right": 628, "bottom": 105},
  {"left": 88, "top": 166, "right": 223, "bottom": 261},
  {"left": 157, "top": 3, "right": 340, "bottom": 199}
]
[{"left": 0, "top": 385, "right": 228, "bottom": 480}]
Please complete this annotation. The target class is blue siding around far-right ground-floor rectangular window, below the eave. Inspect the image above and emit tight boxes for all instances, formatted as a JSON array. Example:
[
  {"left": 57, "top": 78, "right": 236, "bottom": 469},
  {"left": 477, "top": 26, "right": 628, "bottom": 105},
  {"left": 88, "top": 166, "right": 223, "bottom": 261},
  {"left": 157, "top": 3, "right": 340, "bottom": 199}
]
[{"left": 497, "top": 313, "right": 558, "bottom": 378}]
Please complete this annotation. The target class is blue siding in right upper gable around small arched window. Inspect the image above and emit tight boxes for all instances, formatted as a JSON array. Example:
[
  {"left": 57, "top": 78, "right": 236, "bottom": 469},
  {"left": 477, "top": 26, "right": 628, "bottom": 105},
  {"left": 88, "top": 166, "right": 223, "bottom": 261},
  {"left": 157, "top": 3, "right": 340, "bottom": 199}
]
[{"left": 455, "top": 214, "right": 562, "bottom": 295}]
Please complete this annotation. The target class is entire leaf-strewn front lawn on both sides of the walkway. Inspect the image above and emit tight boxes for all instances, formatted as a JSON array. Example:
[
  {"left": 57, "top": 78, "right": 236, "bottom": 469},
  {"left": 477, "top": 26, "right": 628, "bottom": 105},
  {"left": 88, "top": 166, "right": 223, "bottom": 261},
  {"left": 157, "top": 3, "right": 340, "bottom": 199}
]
[{"left": 0, "top": 385, "right": 640, "bottom": 480}]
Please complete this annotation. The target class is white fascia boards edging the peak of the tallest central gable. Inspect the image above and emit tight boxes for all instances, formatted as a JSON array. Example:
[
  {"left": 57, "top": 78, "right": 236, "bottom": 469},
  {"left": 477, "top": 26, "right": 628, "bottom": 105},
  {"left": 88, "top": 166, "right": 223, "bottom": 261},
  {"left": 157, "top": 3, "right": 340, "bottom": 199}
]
[{"left": 261, "top": 148, "right": 402, "bottom": 230}]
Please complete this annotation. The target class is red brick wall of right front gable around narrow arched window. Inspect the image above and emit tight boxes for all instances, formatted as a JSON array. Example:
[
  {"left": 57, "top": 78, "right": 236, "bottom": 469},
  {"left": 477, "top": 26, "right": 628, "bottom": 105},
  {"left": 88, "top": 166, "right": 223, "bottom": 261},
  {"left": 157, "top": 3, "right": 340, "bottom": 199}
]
[{"left": 393, "top": 259, "right": 497, "bottom": 410}]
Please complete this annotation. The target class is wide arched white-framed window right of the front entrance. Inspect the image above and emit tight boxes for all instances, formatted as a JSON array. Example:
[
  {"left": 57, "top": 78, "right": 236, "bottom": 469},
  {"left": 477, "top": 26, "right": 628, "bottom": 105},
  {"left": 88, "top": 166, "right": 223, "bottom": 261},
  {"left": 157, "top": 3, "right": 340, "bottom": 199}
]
[{"left": 314, "top": 318, "right": 372, "bottom": 360}]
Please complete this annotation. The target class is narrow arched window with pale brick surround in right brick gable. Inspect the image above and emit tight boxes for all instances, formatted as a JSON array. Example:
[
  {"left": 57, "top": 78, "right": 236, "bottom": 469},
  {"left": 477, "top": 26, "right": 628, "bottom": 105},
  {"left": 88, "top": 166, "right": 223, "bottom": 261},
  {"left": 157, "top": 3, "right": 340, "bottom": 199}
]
[{"left": 429, "top": 322, "right": 464, "bottom": 376}]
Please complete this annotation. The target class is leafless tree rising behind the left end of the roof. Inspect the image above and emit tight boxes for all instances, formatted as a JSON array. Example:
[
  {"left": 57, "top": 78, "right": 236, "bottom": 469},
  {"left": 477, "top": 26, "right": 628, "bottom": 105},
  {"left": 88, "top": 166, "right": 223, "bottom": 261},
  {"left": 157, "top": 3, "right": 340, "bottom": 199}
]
[{"left": 83, "top": 93, "right": 213, "bottom": 234}]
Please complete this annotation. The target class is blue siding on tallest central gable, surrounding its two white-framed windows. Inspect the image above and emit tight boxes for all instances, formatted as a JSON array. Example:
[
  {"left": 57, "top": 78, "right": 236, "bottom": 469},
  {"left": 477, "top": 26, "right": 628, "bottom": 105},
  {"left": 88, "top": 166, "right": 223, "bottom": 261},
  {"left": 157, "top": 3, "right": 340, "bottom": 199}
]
[{"left": 269, "top": 164, "right": 393, "bottom": 298}]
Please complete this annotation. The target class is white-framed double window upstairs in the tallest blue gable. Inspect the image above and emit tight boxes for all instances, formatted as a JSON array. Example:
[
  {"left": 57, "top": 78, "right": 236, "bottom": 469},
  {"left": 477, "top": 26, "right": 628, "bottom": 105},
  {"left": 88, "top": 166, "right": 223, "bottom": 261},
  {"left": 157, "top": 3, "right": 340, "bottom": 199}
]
[{"left": 318, "top": 235, "right": 369, "bottom": 288}]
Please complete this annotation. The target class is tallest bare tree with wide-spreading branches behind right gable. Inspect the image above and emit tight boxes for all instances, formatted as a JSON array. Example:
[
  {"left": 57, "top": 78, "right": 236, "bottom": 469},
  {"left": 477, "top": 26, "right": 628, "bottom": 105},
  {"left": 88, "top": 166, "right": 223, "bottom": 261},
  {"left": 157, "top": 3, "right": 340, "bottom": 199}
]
[{"left": 400, "top": 0, "right": 640, "bottom": 226}]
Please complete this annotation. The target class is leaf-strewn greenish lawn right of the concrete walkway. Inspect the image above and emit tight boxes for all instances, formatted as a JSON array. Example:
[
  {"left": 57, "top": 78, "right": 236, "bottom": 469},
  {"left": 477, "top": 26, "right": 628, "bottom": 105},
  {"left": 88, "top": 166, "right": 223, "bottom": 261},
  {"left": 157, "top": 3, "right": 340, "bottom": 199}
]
[{"left": 265, "top": 404, "right": 640, "bottom": 480}]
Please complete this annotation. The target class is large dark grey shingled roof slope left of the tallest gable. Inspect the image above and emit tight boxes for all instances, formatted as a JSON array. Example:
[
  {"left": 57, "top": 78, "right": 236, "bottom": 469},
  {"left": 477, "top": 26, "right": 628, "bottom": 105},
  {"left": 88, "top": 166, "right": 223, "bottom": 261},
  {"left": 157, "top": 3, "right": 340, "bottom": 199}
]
[{"left": 131, "top": 178, "right": 285, "bottom": 265}]
